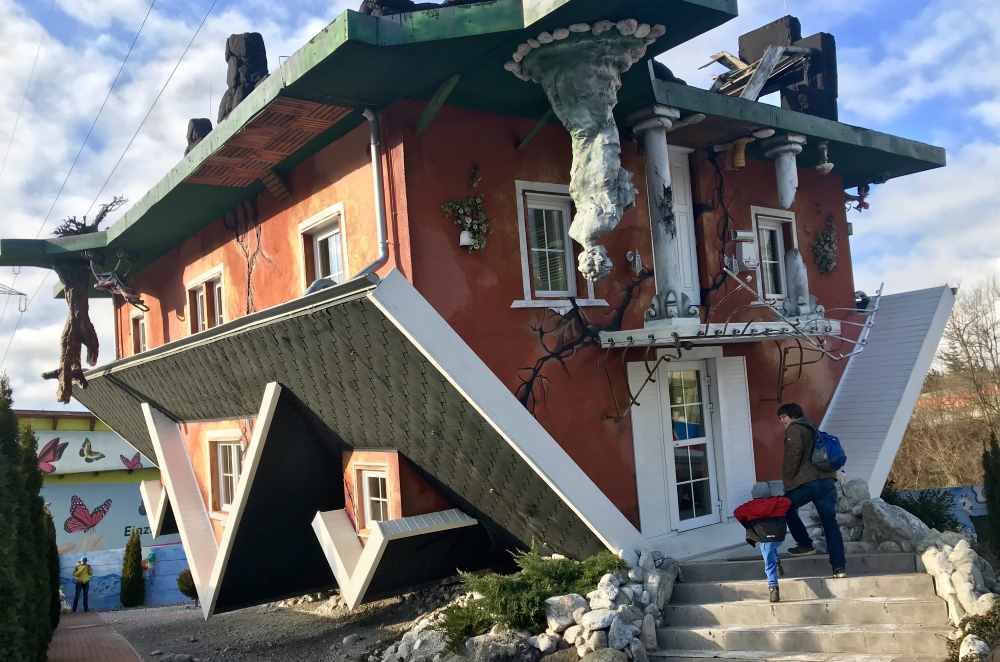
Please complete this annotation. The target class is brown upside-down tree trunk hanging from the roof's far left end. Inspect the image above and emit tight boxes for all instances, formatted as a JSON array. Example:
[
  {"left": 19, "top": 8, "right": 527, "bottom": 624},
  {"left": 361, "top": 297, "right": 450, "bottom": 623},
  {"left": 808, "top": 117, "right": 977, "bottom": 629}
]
[{"left": 42, "top": 197, "right": 125, "bottom": 403}]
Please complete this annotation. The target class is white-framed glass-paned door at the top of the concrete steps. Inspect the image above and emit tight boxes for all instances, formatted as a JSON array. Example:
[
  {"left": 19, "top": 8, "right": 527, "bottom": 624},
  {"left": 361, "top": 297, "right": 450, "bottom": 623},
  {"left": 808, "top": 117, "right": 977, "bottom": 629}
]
[{"left": 660, "top": 361, "right": 722, "bottom": 531}]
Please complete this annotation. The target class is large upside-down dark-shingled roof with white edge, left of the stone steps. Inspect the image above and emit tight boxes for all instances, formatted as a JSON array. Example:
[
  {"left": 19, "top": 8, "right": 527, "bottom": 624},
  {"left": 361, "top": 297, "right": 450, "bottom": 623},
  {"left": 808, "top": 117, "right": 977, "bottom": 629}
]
[{"left": 75, "top": 272, "right": 642, "bottom": 611}]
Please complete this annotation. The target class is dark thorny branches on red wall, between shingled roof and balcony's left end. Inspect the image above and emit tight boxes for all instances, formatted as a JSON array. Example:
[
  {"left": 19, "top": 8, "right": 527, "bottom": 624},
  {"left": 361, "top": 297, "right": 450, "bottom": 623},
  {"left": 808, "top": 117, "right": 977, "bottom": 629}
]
[{"left": 514, "top": 269, "right": 653, "bottom": 413}]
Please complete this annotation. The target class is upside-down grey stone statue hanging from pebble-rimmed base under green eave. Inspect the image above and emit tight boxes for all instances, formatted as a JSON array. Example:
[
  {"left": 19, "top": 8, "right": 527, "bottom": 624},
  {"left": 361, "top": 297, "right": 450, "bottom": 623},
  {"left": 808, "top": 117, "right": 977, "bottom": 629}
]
[{"left": 504, "top": 19, "right": 666, "bottom": 281}]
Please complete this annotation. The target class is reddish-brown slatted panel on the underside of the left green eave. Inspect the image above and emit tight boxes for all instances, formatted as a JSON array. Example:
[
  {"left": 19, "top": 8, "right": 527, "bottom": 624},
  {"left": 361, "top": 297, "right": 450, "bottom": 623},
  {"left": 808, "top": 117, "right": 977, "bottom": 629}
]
[{"left": 186, "top": 97, "right": 351, "bottom": 188}]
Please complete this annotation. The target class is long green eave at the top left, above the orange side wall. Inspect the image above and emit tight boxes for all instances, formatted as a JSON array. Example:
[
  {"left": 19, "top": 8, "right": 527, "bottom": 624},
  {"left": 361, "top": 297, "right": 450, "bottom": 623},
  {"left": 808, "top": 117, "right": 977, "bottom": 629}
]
[{"left": 11, "top": 0, "right": 736, "bottom": 269}]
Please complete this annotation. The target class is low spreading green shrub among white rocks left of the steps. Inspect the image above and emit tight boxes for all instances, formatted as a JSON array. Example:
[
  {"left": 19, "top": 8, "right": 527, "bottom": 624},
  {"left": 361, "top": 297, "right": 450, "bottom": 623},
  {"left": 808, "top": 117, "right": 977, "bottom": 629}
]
[{"left": 444, "top": 549, "right": 627, "bottom": 651}]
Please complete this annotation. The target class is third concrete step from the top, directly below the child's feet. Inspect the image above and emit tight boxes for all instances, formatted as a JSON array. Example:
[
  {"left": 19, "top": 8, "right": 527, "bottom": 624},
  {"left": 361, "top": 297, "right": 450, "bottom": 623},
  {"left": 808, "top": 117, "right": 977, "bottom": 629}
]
[{"left": 664, "top": 597, "right": 948, "bottom": 627}]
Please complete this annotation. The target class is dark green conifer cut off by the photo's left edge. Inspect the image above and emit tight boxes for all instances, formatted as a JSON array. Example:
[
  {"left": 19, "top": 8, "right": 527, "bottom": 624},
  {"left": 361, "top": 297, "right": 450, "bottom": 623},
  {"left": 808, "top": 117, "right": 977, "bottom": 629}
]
[{"left": 0, "top": 375, "right": 27, "bottom": 660}]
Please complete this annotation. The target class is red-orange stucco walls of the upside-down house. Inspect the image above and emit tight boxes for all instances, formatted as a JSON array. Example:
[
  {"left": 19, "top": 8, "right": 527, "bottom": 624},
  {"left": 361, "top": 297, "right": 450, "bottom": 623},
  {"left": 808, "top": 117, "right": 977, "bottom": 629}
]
[{"left": 123, "top": 98, "right": 854, "bottom": 536}]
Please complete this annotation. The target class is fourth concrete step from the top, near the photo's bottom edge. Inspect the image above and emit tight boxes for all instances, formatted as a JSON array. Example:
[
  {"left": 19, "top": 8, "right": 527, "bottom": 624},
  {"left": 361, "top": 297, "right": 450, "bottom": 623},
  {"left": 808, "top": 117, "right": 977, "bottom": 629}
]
[{"left": 657, "top": 624, "right": 951, "bottom": 659}]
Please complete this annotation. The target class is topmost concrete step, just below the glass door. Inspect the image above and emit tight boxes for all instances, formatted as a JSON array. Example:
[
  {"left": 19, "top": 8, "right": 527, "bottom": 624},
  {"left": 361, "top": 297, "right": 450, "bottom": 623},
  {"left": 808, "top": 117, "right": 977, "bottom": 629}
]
[{"left": 681, "top": 553, "right": 917, "bottom": 582}]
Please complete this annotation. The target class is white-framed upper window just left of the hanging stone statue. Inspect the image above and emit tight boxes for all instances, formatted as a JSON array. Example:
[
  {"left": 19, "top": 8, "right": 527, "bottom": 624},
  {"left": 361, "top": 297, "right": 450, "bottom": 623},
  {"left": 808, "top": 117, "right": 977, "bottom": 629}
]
[{"left": 510, "top": 180, "right": 608, "bottom": 311}]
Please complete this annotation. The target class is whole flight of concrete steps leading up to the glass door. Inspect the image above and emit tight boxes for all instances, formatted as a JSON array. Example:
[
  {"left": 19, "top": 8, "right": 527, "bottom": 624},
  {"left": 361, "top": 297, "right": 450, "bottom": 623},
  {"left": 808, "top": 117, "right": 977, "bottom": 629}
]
[{"left": 650, "top": 554, "right": 951, "bottom": 662}]
